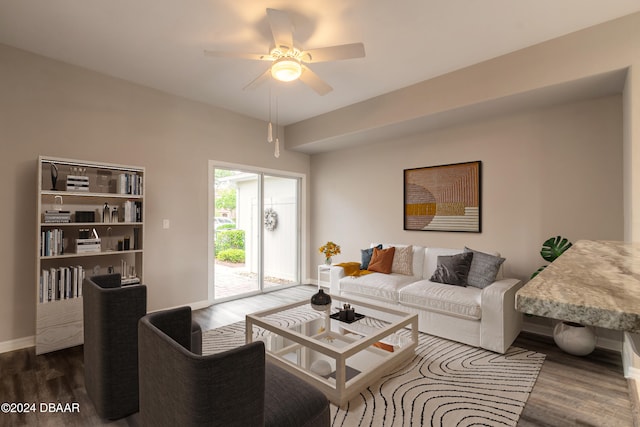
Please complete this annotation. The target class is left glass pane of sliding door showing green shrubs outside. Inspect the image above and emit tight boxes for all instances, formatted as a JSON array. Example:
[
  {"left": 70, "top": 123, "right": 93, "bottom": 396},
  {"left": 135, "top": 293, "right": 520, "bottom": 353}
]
[{"left": 214, "top": 169, "right": 260, "bottom": 300}]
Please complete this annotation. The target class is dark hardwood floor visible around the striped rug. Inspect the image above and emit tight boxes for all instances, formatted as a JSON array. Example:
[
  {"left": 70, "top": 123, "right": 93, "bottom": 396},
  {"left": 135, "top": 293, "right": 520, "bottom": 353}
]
[{"left": 0, "top": 286, "right": 634, "bottom": 427}]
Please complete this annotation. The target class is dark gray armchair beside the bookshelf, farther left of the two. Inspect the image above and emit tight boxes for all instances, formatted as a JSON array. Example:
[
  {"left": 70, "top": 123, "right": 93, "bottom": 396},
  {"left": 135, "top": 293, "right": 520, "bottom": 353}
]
[{"left": 82, "top": 274, "right": 147, "bottom": 419}]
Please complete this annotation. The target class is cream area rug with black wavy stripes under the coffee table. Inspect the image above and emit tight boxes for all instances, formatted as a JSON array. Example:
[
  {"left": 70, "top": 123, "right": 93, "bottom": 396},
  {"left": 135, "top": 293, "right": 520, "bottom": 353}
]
[{"left": 202, "top": 310, "right": 544, "bottom": 427}]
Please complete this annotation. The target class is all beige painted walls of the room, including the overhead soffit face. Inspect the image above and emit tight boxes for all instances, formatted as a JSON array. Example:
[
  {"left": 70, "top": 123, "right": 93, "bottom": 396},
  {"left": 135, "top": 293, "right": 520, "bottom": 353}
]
[{"left": 0, "top": 13, "right": 640, "bottom": 350}]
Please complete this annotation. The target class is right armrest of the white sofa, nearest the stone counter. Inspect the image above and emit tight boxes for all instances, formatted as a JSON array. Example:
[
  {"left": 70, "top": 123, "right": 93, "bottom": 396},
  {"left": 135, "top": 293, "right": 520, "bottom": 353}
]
[{"left": 480, "top": 279, "right": 523, "bottom": 353}]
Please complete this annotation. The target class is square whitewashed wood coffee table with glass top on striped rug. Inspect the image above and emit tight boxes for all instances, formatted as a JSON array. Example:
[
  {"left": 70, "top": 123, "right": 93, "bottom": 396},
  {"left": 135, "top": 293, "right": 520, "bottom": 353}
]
[{"left": 246, "top": 296, "right": 418, "bottom": 406}]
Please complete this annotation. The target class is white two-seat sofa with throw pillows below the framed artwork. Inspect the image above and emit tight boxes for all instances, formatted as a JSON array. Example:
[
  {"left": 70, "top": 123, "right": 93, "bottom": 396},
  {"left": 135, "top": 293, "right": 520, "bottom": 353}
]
[{"left": 330, "top": 244, "right": 523, "bottom": 353}]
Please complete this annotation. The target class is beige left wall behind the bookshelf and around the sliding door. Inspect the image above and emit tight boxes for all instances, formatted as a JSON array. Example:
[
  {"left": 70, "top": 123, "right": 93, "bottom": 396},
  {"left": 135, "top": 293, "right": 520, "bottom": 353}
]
[{"left": 0, "top": 41, "right": 309, "bottom": 344}]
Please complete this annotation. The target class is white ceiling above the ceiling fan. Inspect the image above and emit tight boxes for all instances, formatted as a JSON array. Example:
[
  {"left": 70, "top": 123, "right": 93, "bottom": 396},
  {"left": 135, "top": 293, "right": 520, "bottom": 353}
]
[{"left": 0, "top": 0, "right": 640, "bottom": 124}]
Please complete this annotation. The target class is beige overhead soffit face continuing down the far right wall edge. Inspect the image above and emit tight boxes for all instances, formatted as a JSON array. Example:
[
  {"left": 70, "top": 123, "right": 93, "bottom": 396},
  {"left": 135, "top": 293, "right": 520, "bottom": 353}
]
[{"left": 292, "top": 13, "right": 640, "bottom": 246}]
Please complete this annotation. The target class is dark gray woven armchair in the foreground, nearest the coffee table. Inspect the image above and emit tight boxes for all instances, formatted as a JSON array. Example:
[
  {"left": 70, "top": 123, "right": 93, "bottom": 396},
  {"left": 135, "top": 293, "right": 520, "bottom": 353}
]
[{"left": 138, "top": 307, "right": 330, "bottom": 427}]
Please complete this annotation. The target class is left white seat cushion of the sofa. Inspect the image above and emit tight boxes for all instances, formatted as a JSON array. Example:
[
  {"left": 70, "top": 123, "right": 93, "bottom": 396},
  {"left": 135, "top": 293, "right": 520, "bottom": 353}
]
[{"left": 340, "top": 273, "right": 415, "bottom": 303}]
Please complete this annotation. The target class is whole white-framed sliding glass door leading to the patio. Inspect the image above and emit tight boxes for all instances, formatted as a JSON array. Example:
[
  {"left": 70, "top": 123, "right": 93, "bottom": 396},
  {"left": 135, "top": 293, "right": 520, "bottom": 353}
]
[{"left": 210, "top": 166, "right": 300, "bottom": 301}]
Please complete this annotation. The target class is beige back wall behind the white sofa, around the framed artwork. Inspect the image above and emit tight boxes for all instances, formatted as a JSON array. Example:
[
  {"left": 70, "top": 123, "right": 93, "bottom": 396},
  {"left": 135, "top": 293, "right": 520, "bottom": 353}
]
[{"left": 310, "top": 95, "right": 623, "bottom": 279}]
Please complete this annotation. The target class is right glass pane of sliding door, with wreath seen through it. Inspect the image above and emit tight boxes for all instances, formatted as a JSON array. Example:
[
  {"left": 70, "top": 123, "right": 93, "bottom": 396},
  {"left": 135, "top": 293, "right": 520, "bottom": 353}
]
[{"left": 263, "top": 175, "right": 300, "bottom": 289}]
